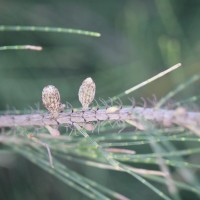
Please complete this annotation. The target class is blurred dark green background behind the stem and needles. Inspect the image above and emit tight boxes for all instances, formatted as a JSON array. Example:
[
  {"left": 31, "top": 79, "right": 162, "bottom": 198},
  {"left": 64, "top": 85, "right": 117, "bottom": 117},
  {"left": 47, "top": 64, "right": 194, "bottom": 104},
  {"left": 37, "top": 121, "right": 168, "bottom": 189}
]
[{"left": 0, "top": 0, "right": 200, "bottom": 200}]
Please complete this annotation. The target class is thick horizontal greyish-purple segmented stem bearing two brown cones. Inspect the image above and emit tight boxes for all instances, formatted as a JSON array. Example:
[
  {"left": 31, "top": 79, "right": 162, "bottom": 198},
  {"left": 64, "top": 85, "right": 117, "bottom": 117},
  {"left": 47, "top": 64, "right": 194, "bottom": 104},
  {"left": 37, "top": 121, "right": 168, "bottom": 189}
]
[{"left": 0, "top": 107, "right": 200, "bottom": 131}]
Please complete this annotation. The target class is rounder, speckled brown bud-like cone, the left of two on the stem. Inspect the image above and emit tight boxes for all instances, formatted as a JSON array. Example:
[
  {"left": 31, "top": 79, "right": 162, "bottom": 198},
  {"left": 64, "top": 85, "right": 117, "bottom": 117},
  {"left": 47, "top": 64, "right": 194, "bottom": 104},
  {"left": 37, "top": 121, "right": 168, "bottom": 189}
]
[{"left": 42, "top": 85, "right": 61, "bottom": 117}]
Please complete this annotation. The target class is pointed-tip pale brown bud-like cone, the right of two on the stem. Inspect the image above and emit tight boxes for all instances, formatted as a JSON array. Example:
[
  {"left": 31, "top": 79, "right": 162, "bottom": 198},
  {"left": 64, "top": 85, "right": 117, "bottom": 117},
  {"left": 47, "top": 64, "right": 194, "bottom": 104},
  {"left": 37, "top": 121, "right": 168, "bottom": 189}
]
[{"left": 78, "top": 77, "right": 96, "bottom": 110}]
